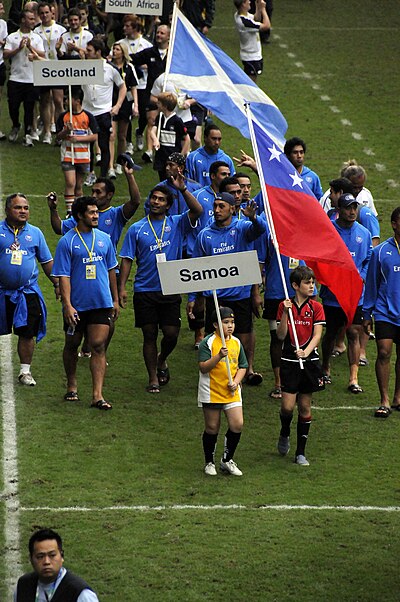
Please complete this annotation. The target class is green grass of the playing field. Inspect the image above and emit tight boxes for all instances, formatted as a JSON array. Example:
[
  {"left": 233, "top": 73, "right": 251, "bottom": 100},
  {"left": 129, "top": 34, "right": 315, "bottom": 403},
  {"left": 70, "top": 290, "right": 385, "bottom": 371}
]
[{"left": 0, "top": 0, "right": 400, "bottom": 602}]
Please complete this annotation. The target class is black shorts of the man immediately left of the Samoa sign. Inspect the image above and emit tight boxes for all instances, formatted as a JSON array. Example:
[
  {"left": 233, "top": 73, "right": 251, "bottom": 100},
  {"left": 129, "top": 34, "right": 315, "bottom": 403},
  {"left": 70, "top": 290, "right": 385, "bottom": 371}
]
[{"left": 133, "top": 291, "right": 182, "bottom": 328}]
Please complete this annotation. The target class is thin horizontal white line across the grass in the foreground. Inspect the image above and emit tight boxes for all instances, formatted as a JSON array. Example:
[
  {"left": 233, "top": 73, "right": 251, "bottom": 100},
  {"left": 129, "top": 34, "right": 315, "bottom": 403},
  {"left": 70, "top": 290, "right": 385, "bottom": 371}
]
[{"left": 21, "top": 504, "right": 400, "bottom": 512}]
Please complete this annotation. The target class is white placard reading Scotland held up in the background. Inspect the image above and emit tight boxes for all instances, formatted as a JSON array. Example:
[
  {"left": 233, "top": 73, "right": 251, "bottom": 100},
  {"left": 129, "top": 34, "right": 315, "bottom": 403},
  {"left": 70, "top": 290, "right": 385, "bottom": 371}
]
[{"left": 33, "top": 59, "right": 104, "bottom": 86}]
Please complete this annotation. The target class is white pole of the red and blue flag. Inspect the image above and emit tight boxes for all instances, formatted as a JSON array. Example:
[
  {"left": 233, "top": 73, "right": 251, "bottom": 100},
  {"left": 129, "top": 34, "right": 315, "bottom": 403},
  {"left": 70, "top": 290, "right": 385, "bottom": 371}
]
[{"left": 245, "top": 103, "right": 304, "bottom": 369}]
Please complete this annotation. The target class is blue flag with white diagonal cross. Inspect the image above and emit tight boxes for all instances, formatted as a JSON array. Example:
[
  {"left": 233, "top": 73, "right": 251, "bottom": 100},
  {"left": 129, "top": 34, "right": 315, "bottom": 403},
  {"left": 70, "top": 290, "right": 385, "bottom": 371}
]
[{"left": 166, "top": 5, "right": 287, "bottom": 146}]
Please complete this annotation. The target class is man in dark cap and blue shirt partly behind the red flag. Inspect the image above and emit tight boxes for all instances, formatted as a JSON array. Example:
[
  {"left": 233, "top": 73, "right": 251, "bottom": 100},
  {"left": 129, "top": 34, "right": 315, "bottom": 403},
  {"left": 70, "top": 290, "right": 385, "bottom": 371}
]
[{"left": 320, "top": 193, "right": 372, "bottom": 394}]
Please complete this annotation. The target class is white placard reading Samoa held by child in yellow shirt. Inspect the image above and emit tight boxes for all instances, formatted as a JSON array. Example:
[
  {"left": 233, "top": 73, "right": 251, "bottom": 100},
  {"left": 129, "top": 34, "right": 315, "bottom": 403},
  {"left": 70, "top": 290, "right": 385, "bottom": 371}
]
[{"left": 157, "top": 251, "right": 261, "bottom": 295}]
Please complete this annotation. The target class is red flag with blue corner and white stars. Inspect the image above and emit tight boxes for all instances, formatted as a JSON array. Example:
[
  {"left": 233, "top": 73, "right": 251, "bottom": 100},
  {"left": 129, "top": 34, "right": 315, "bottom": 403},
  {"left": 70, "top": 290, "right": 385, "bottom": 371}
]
[{"left": 253, "top": 121, "right": 363, "bottom": 324}]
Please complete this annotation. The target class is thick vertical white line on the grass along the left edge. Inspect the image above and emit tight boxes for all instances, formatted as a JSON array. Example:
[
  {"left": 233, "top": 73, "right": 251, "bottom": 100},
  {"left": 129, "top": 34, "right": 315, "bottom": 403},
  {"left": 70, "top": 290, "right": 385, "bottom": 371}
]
[{"left": 0, "top": 173, "right": 22, "bottom": 600}]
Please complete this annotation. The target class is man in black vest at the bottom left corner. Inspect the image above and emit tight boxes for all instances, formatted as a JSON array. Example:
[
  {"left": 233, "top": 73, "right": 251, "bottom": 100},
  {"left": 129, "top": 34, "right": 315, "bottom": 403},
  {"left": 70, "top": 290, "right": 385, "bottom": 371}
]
[{"left": 14, "top": 529, "right": 99, "bottom": 602}]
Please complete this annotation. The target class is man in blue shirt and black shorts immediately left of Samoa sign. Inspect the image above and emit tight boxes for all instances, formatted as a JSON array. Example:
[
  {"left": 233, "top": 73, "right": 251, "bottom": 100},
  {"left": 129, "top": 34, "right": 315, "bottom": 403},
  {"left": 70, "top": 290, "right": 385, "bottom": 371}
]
[{"left": 119, "top": 173, "right": 202, "bottom": 393}]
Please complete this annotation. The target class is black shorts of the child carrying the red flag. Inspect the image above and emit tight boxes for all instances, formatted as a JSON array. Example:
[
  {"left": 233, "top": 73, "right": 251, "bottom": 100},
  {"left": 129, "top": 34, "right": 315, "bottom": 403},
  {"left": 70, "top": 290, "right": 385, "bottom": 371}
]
[{"left": 280, "top": 359, "right": 325, "bottom": 394}]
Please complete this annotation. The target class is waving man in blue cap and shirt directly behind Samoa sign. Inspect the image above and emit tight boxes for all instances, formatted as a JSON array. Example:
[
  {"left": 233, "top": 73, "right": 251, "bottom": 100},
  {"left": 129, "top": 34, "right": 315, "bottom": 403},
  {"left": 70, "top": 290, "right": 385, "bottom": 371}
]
[{"left": 187, "top": 192, "right": 267, "bottom": 384}]
